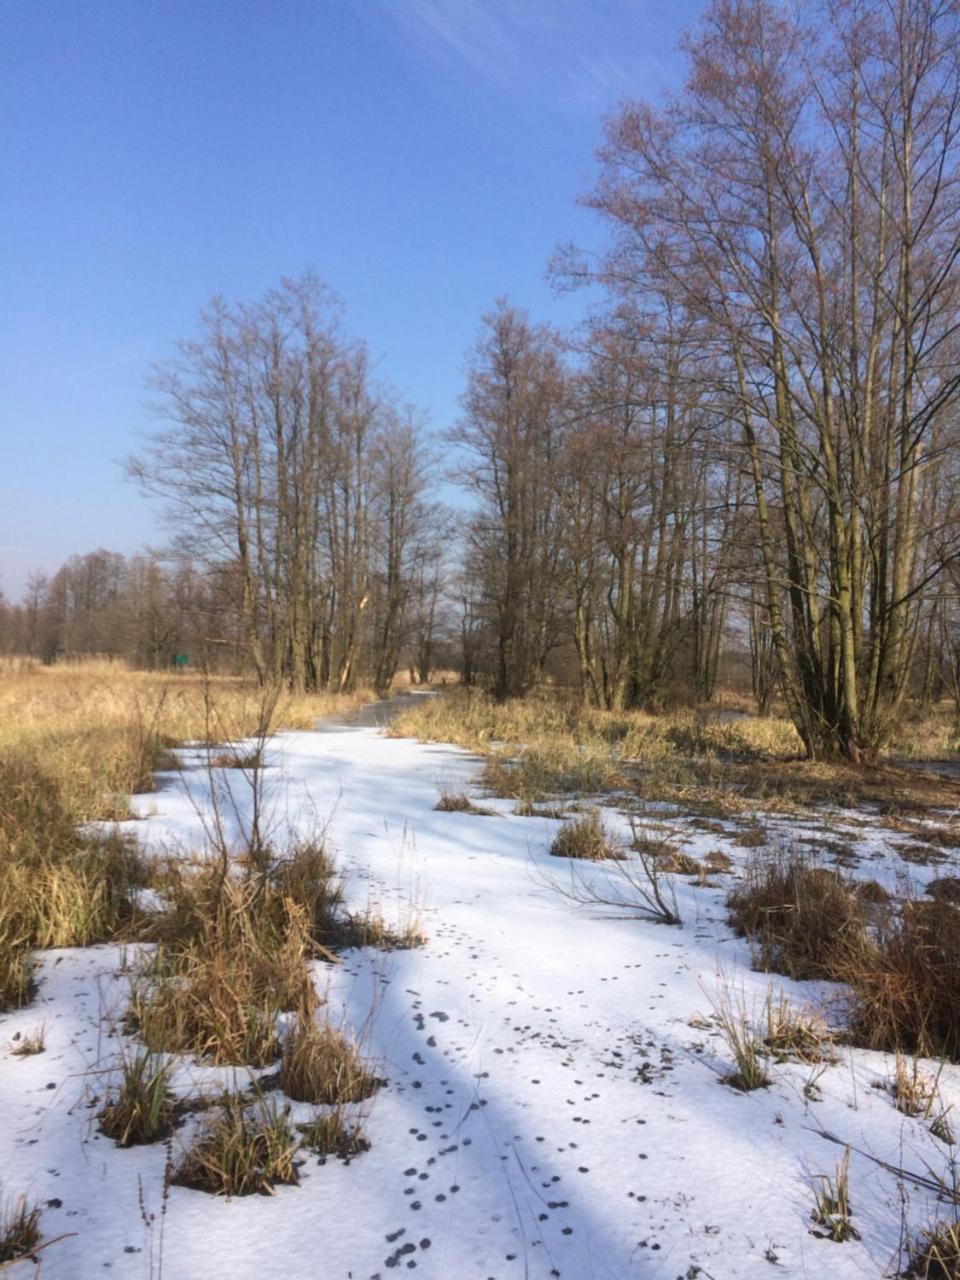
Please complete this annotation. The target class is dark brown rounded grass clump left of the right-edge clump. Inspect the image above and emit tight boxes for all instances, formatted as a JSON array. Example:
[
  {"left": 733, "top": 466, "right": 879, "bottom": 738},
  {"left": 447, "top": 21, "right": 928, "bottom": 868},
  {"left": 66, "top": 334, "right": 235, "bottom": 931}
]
[{"left": 727, "top": 851, "right": 865, "bottom": 979}]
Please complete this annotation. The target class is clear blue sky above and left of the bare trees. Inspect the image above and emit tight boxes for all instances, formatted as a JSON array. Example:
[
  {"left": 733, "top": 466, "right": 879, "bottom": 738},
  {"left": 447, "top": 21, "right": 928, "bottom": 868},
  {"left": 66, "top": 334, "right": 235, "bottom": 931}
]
[{"left": 0, "top": 0, "right": 703, "bottom": 596}]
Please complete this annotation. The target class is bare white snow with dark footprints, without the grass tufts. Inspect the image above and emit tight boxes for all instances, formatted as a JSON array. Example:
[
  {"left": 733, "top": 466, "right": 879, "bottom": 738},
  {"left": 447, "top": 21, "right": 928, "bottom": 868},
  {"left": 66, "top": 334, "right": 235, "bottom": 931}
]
[{"left": 0, "top": 711, "right": 960, "bottom": 1280}]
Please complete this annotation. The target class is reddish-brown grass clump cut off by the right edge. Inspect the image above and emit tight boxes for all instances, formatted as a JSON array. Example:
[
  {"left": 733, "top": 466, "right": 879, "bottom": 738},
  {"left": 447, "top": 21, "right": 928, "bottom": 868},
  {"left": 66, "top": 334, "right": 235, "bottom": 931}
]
[{"left": 836, "top": 900, "right": 960, "bottom": 1061}]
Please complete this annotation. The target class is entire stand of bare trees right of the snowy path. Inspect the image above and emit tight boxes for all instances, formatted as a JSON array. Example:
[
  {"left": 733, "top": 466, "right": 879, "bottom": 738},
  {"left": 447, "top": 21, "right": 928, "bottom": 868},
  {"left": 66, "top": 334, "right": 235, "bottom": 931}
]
[{"left": 456, "top": 0, "right": 960, "bottom": 760}]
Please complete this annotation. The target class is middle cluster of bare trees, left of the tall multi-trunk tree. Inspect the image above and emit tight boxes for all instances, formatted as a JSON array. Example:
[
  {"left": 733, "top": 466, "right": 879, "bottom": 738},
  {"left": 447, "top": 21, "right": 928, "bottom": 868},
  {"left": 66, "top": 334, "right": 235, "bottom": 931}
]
[{"left": 452, "top": 302, "right": 737, "bottom": 708}]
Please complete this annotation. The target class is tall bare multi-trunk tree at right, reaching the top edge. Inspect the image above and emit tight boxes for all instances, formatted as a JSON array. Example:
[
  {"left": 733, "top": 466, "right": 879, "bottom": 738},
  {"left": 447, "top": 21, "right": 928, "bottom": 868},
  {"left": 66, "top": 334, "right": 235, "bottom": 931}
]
[{"left": 578, "top": 0, "right": 960, "bottom": 760}]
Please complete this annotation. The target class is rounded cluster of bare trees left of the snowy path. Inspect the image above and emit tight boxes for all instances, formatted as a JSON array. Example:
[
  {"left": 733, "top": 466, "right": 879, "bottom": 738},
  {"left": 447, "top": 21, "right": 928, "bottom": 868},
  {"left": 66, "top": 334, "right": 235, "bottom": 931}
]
[{"left": 129, "top": 275, "right": 444, "bottom": 691}]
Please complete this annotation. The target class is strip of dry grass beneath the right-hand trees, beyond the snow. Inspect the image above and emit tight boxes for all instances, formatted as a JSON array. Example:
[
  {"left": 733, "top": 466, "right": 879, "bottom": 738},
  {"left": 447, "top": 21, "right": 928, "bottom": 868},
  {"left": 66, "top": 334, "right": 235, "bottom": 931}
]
[{"left": 390, "top": 690, "right": 960, "bottom": 841}]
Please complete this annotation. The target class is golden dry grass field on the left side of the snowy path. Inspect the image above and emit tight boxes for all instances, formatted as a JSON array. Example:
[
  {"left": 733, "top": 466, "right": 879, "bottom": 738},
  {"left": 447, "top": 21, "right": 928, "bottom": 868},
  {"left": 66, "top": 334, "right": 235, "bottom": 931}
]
[{"left": 0, "top": 662, "right": 370, "bottom": 1009}]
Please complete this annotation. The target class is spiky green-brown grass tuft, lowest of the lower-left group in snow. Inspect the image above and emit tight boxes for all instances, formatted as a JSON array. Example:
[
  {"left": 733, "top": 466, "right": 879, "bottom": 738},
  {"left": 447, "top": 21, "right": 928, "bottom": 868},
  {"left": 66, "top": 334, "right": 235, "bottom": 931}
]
[{"left": 170, "top": 1094, "right": 300, "bottom": 1196}]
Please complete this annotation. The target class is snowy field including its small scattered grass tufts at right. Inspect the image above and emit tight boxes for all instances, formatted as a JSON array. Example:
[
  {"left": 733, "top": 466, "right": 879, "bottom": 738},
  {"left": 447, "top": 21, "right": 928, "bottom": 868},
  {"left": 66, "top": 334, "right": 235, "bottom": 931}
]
[{"left": 0, "top": 675, "right": 960, "bottom": 1280}]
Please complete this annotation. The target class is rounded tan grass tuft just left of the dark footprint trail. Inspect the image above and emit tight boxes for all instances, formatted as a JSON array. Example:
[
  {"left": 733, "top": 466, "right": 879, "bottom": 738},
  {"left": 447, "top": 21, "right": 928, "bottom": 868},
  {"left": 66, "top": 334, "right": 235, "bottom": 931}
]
[{"left": 280, "top": 1014, "right": 381, "bottom": 1105}]
